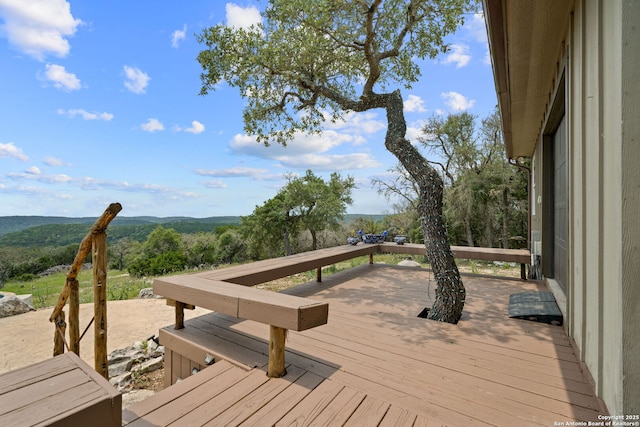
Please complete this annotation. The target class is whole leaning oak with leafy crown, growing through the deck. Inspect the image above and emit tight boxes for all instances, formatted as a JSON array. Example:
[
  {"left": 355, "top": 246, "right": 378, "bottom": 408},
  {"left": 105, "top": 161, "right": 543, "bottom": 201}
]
[{"left": 198, "top": 0, "right": 474, "bottom": 323}]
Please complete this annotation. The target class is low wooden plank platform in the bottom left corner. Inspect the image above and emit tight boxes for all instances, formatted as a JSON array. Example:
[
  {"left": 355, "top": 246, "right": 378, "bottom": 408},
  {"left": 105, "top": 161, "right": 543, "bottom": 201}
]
[{"left": 0, "top": 352, "right": 122, "bottom": 427}]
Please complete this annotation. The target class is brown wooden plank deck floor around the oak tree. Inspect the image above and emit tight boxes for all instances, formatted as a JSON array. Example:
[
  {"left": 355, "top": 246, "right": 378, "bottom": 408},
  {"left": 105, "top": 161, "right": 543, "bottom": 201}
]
[{"left": 123, "top": 264, "right": 601, "bottom": 426}]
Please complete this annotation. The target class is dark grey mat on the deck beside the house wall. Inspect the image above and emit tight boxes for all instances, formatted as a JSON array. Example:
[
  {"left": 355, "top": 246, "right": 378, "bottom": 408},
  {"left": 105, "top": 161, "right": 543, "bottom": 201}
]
[{"left": 509, "top": 292, "right": 563, "bottom": 325}]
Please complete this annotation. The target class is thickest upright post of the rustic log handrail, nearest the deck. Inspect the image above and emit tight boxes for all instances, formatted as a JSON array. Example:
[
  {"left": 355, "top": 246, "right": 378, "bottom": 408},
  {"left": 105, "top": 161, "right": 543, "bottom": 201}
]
[{"left": 93, "top": 231, "right": 109, "bottom": 379}]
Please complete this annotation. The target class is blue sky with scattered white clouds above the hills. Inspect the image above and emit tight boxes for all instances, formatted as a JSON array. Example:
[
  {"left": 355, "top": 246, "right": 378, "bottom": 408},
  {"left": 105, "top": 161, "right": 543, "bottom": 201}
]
[{"left": 0, "top": 0, "right": 496, "bottom": 217}]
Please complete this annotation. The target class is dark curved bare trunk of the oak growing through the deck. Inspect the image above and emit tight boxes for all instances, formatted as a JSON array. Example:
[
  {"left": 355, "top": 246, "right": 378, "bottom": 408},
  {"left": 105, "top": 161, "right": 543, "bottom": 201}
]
[{"left": 381, "top": 90, "right": 466, "bottom": 323}]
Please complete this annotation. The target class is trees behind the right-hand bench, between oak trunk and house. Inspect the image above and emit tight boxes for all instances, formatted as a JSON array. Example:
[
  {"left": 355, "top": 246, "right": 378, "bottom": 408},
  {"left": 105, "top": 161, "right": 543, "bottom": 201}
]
[{"left": 372, "top": 109, "right": 529, "bottom": 248}]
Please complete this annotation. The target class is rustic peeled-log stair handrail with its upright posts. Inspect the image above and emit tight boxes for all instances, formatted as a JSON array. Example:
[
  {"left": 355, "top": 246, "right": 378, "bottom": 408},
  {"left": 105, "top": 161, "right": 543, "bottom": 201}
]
[{"left": 49, "top": 203, "right": 122, "bottom": 378}]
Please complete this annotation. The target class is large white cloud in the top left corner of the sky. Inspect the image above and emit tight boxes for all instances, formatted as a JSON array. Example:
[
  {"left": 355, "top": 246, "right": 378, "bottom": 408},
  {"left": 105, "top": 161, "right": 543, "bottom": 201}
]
[{"left": 0, "top": 0, "right": 82, "bottom": 61}]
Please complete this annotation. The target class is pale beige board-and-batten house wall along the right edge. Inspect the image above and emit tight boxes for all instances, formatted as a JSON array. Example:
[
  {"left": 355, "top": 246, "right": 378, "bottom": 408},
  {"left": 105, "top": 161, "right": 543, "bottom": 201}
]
[{"left": 532, "top": 0, "right": 640, "bottom": 415}]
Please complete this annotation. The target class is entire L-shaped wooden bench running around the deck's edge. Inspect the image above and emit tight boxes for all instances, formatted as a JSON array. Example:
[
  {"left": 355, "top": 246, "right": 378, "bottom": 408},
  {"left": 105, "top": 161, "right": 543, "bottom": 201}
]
[{"left": 154, "top": 243, "right": 530, "bottom": 382}]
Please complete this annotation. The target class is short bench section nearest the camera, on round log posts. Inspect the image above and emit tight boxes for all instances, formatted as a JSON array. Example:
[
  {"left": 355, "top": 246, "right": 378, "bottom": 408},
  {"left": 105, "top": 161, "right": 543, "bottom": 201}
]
[{"left": 153, "top": 275, "right": 329, "bottom": 377}]
